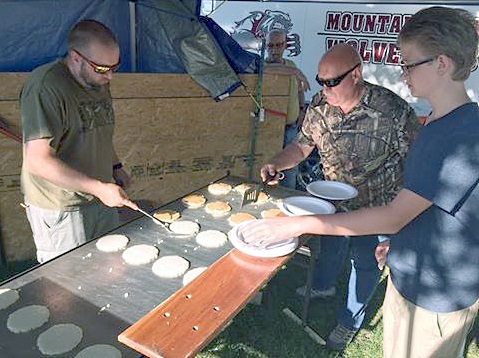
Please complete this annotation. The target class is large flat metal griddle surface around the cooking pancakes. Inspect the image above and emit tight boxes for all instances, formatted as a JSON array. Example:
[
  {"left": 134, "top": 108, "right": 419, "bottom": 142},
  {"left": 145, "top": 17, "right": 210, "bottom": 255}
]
[{"left": 0, "top": 177, "right": 298, "bottom": 357}]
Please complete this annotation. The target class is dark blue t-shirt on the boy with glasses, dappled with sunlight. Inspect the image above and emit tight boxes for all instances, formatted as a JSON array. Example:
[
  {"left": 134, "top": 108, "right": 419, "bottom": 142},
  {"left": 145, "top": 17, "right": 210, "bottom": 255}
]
[{"left": 388, "top": 103, "right": 479, "bottom": 312}]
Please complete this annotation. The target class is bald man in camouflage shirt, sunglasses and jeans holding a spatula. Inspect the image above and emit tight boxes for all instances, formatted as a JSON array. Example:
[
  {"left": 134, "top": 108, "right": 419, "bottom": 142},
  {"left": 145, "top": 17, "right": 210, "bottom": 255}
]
[{"left": 261, "top": 44, "right": 417, "bottom": 350}]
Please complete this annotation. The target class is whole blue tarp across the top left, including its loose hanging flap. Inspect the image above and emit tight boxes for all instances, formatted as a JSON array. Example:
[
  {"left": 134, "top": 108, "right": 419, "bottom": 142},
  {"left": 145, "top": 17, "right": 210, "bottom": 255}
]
[{"left": 0, "top": 0, "right": 258, "bottom": 100}]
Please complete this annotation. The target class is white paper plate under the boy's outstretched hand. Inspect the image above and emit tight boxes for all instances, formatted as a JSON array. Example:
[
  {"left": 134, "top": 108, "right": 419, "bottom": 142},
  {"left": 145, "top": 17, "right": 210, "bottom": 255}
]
[{"left": 228, "top": 220, "right": 298, "bottom": 257}]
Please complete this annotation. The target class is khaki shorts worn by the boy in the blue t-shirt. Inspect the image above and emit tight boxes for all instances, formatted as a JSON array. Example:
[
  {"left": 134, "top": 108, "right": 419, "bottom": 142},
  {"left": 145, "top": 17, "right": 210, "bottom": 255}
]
[{"left": 383, "top": 278, "right": 479, "bottom": 358}]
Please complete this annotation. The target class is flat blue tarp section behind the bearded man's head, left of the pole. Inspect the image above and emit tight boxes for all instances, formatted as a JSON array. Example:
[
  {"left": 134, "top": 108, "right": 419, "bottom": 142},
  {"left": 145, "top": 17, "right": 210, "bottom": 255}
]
[{"left": 0, "top": 0, "right": 131, "bottom": 72}]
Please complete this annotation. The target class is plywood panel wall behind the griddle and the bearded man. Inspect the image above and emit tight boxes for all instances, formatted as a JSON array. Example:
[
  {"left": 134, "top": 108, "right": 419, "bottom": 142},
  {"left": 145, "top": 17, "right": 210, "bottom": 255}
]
[{"left": 0, "top": 74, "right": 288, "bottom": 261}]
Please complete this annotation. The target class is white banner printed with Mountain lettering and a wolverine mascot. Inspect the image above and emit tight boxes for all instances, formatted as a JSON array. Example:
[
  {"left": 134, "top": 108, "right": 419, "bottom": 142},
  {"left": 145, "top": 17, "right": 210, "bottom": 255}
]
[{"left": 202, "top": 1, "right": 479, "bottom": 115}]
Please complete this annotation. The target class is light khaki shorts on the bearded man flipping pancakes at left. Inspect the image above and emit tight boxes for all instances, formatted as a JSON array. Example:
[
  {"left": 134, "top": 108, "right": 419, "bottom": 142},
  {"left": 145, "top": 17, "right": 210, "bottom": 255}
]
[{"left": 26, "top": 202, "right": 119, "bottom": 263}]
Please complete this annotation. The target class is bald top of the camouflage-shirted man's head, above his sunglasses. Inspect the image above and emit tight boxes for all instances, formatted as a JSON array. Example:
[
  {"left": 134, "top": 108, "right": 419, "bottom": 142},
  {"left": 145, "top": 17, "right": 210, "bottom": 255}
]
[{"left": 318, "top": 43, "right": 361, "bottom": 78}]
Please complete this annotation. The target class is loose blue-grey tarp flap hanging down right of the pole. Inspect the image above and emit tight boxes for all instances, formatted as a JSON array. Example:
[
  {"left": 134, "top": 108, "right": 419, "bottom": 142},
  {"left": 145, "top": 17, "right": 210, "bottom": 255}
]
[{"left": 136, "top": 0, "right": 246, "bottom": 100}]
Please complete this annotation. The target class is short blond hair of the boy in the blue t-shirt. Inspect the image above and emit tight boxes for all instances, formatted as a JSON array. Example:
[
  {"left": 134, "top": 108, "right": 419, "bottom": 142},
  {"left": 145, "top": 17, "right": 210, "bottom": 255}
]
[{"left": 398, "top": 6, "right": 478, "bottom": 81}]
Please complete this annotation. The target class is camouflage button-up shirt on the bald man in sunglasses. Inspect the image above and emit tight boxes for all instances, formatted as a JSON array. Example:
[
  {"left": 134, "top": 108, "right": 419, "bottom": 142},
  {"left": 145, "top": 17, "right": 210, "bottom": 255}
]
[{"left": 295, "top": 82, "right": 418, "bottom": 210}]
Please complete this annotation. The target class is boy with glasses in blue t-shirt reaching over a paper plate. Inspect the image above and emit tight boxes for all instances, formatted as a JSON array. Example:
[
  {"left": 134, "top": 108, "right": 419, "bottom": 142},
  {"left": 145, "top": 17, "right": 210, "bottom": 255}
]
[{"left": 242, "top": 6, "right": 479, "bottom": 358}]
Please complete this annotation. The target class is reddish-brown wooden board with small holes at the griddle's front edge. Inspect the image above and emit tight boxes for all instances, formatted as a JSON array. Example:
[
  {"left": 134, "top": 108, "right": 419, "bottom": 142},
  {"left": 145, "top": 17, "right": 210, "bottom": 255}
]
[{"left": 118, "top": 249, "right": 293, "bottom": 358}]
